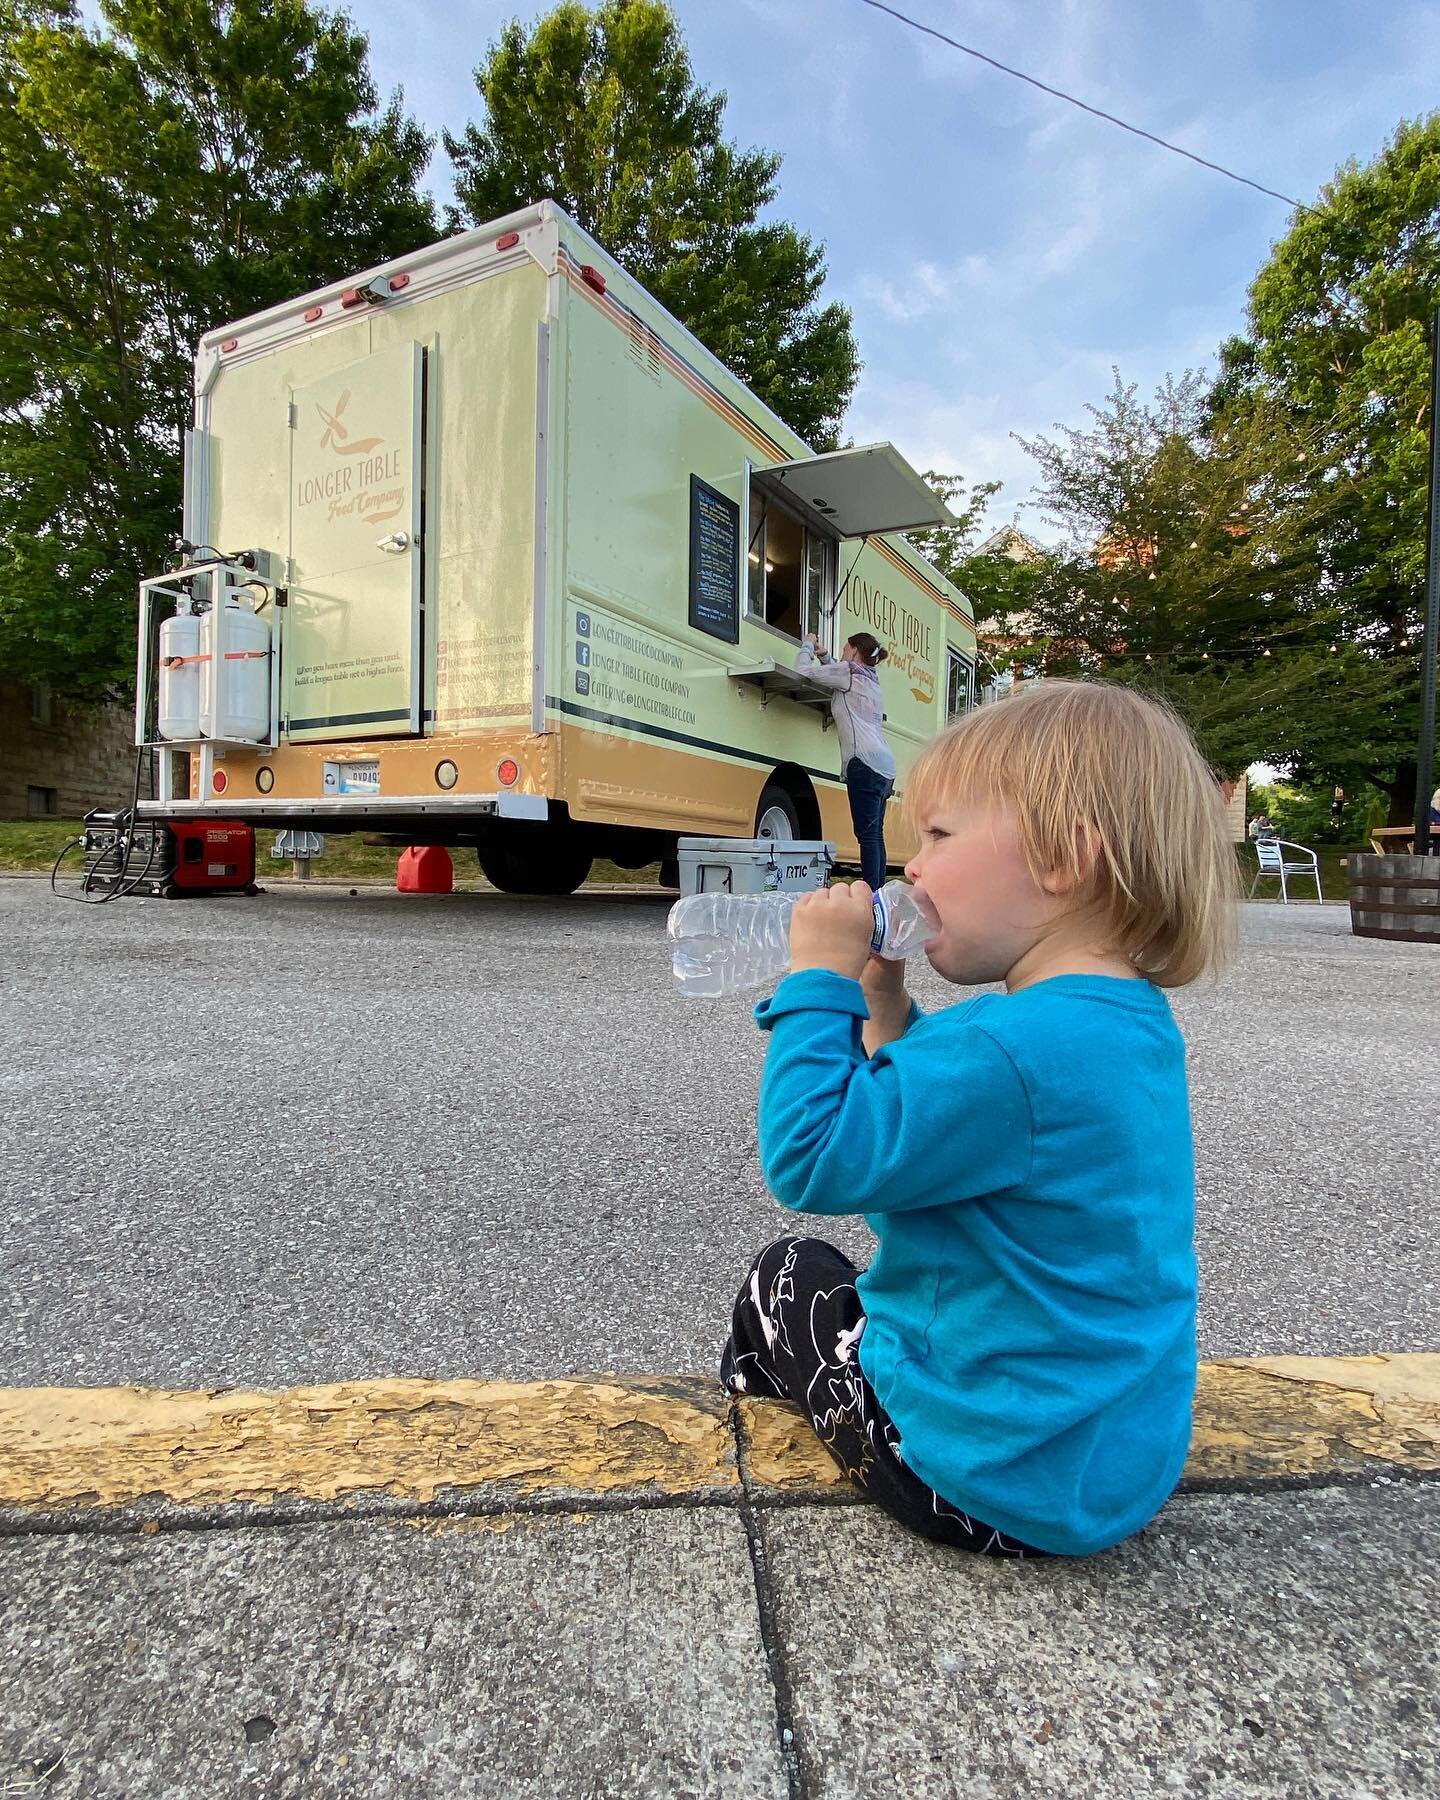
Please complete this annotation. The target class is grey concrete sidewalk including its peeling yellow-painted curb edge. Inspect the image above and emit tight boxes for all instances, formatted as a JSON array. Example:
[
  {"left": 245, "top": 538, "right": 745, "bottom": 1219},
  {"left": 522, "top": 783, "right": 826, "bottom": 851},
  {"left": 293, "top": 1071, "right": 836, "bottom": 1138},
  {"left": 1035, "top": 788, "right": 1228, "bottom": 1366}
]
[{"left": 0, "top": 1355, "right": 1440, "bottom": 1800}]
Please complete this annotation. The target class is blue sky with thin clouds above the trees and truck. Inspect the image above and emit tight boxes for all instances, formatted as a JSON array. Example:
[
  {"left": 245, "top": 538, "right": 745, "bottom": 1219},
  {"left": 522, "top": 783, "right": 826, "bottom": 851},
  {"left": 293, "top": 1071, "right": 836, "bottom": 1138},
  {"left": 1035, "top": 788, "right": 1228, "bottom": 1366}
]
[{"left": 103, "top": 0, "right": 1440, "bottom": 536}]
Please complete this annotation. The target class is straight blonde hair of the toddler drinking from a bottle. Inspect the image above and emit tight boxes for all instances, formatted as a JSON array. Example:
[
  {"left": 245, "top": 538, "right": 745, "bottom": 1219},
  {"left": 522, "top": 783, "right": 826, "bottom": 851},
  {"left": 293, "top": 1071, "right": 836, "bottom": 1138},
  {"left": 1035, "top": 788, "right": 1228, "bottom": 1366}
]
[{"left": 905, "top": 680, "right": 1238, "bottom": 988}]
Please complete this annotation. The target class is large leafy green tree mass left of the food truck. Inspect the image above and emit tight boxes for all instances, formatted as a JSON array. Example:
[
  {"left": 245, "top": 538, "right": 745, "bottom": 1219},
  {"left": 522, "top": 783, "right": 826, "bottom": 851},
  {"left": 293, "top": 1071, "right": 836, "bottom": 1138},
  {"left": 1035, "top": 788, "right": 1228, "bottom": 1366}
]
[{"left": 0, "top": 0, "right": 436, "bottom": 695}]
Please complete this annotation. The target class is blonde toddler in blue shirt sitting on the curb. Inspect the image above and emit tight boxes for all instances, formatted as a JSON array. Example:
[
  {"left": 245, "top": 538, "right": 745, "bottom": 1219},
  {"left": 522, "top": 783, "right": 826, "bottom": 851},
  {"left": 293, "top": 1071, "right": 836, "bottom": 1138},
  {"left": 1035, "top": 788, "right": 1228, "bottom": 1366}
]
[{"left": 720, "top": 680, "right": 1237, "bottom": 1557}]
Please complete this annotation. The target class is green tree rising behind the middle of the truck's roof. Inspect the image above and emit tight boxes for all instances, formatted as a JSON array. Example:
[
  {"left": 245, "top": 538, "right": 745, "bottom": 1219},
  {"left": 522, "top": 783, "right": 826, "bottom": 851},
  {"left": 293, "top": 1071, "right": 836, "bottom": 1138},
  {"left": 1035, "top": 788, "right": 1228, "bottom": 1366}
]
[{"left": 445, "top": 0, "right": 860, "bottom": 448}]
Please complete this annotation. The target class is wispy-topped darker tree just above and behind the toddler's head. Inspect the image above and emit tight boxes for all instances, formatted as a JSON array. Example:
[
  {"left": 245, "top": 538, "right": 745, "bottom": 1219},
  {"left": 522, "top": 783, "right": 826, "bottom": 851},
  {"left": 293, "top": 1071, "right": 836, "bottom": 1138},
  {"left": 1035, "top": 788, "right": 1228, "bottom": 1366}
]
[{"left": 993, "top": 373, "right": 1408, "bottom": 783}]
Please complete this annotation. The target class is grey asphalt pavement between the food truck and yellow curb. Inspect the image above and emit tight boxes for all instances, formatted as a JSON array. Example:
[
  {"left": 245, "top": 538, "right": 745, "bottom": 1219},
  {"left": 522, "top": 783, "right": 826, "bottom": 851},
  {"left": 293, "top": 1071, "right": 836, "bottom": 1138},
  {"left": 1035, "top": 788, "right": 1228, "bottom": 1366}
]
[{"left": 0, "top": 880, "right": 1440, "bottom": 1388}]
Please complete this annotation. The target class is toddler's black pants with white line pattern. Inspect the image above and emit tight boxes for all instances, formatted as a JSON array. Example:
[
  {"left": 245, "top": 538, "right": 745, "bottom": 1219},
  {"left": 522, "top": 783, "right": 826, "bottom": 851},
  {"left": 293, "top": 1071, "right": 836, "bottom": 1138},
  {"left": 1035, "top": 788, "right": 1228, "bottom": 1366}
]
[{"left": 720, "top": 1237, "right": 1046, "bottom": 1557}]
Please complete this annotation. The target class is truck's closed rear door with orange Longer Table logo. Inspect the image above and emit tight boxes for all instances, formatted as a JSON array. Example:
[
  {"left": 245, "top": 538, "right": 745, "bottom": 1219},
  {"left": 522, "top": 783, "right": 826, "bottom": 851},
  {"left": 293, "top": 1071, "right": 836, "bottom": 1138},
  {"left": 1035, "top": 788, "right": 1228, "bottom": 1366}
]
[{"left": 281, "top": 342, "right": 425, "bottom": 742}]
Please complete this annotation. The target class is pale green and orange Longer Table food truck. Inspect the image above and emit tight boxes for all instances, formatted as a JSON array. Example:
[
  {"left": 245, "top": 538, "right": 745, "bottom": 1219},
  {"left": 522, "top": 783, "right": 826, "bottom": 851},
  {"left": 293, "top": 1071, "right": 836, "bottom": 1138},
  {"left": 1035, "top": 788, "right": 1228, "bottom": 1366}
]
[{"left": 137, "top": 202, "right": 976, "bottom": 893}]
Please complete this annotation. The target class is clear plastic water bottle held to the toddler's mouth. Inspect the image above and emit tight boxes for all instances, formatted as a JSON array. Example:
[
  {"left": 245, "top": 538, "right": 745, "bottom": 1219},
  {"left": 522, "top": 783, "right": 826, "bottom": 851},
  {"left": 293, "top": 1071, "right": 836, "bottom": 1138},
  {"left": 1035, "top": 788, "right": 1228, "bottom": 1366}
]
[{"left": 666, "top": 882, "right": 934, "bottom": 1001}]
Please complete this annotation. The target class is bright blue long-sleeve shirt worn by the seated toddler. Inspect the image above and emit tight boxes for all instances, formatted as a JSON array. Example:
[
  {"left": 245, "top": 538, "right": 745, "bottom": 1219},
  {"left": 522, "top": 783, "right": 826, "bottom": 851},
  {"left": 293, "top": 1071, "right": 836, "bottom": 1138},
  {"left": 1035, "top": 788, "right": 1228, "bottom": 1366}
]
[{"left": 756, "top": 970, "right": 1195, "bottom": 1555}]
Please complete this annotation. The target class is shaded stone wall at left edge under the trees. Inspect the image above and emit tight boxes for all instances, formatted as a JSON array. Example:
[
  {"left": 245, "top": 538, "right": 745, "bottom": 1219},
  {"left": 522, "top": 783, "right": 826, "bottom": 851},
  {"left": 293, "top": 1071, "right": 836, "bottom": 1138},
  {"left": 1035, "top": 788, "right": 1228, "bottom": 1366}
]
[{"left": 0, "top": 680, "right": 149, "bottom": 819}]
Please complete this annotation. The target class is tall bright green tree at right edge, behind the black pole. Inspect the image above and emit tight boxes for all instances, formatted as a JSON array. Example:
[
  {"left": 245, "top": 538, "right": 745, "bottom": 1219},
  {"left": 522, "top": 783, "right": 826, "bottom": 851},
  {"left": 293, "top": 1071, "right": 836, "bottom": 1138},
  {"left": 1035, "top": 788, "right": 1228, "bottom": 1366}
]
[{"left": 1217, "top": 113, "right": 1440, "bottom": 817}]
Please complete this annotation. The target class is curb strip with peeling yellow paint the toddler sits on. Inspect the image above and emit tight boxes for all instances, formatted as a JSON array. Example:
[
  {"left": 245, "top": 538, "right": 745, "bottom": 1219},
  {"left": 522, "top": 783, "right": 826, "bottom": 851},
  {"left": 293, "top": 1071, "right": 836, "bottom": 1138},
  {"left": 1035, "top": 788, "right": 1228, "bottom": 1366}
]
[{"left": 0, "top": 1355, "right": 1440, "bottom": 1534}]
